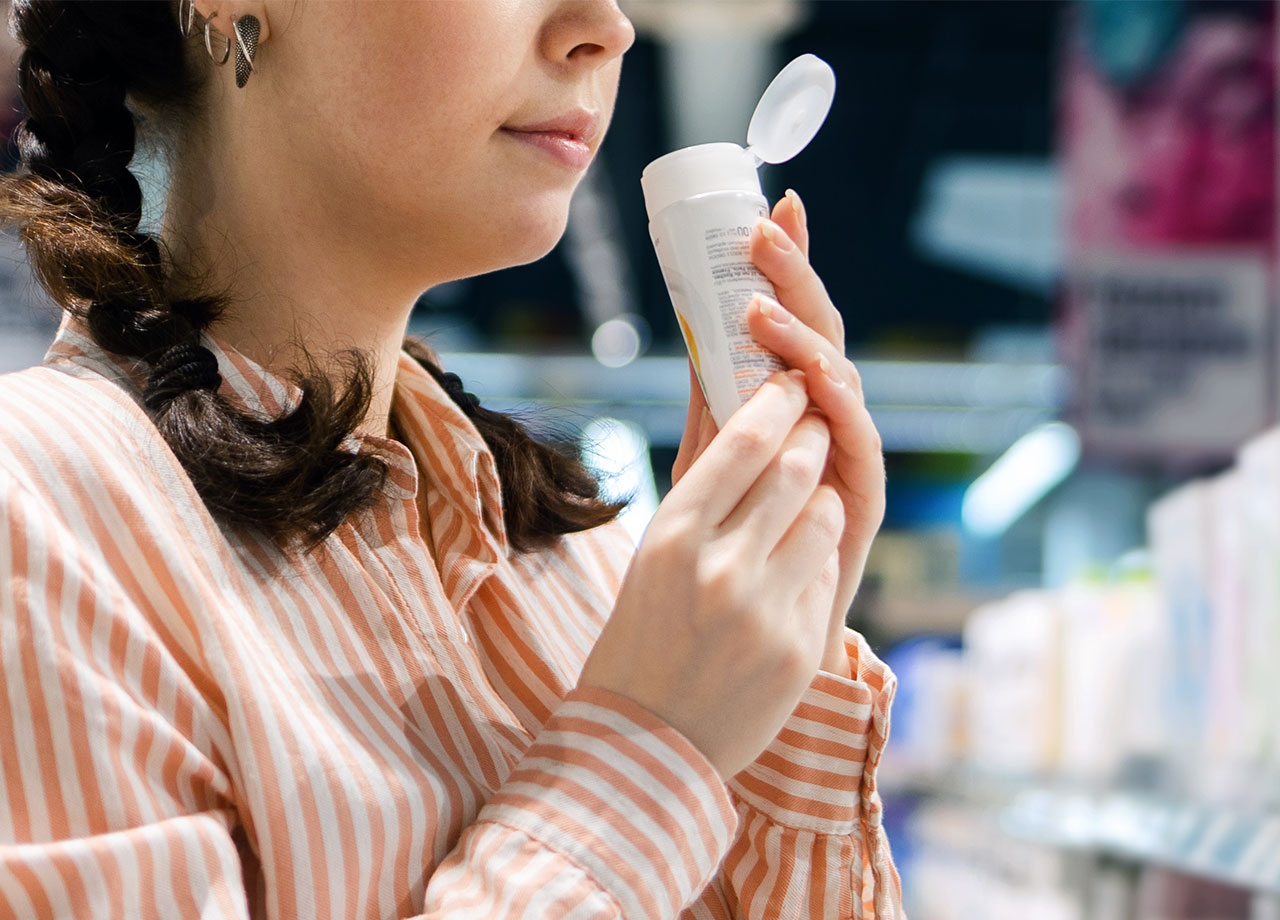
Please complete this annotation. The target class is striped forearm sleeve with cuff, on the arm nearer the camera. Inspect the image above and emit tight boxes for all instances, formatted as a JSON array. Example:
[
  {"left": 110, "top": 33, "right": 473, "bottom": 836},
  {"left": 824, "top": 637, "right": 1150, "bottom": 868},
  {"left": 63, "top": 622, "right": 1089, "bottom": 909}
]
[{"left": 425, "top": 687, "right": 737, "bottom": 920}]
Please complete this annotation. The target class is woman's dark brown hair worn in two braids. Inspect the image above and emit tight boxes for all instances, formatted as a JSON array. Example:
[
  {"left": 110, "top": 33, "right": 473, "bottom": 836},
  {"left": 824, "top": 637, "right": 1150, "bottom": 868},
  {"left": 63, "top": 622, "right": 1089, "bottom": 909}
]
[{"left": 0, "top": 0, "right": 626, "bottom": 551}]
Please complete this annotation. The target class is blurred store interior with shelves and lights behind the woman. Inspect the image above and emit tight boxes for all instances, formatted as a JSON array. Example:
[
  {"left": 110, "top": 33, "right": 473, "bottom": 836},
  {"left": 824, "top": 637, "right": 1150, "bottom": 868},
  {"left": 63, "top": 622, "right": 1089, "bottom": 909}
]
[{"left": 0, "top": 0, "right": 1280, "bottom": 920}]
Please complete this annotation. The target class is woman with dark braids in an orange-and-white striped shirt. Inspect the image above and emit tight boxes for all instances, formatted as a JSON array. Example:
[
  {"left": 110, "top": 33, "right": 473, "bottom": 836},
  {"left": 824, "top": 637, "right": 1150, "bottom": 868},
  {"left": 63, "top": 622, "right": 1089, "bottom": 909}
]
[{"left": 0, "top": 0, "right": 900, "bottom": 919}]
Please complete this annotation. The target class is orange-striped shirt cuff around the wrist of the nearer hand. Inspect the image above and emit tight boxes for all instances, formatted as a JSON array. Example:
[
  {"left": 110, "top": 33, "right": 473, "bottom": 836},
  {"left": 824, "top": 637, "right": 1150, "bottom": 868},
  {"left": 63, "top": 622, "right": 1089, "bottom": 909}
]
[{"left": 477, "top": 687, "right": 737, "bottom": 917}]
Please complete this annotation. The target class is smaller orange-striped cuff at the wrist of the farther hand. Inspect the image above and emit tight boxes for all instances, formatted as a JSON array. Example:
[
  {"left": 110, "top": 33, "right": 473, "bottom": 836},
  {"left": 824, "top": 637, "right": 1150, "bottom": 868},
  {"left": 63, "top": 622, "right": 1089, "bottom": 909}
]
[{"left": 728, "top": 630, "right": 897, "bottom": 834}]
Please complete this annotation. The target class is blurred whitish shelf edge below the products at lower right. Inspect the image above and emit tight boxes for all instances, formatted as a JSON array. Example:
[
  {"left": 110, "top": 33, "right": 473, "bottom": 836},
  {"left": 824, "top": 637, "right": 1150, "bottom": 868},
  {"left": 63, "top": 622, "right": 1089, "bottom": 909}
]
[{"left": 887, "top": 777, "right": 1280, "bottom": 896}]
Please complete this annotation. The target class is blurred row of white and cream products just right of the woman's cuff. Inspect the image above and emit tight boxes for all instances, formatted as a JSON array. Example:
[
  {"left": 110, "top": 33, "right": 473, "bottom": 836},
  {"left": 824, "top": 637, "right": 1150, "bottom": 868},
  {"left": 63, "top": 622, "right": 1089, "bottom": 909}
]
[{"left": 886, "top": 576, "right": 1166, "bottom": 782}]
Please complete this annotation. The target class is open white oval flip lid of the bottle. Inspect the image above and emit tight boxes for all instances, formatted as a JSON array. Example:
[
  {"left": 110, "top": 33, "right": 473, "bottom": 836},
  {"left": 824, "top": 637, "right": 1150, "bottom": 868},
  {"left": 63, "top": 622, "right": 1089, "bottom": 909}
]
[{"left": 746, "top": 54, "right": 836, "bottom": 166}]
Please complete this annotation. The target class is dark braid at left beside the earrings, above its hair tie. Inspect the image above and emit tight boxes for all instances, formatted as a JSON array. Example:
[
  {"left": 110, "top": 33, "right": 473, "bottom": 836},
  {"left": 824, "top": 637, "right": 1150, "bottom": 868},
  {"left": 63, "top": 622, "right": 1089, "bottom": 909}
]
[{"left": 14, "top": 3, "right": 207, "bottom": 371}]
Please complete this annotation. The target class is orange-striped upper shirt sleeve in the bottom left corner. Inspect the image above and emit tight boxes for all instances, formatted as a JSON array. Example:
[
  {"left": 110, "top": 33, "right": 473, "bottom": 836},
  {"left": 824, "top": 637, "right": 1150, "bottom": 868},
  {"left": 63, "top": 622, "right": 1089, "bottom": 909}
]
[{"left": 0, "top": 473, "right": 248, "bottom": 920}]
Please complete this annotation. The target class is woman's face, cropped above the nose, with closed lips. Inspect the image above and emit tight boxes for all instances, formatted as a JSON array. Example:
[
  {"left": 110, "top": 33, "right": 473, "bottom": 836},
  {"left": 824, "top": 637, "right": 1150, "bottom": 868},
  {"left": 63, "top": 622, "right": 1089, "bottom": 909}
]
[{"left": 245, "top": 0, "right": 635, "bottom": 287}]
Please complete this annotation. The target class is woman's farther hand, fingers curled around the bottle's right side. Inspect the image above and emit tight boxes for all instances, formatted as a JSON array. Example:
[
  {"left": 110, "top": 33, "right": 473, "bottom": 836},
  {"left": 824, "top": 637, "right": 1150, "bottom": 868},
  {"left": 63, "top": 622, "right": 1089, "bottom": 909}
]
[{"left": 748, "top": 189, "right": 884, "bottom": 676}]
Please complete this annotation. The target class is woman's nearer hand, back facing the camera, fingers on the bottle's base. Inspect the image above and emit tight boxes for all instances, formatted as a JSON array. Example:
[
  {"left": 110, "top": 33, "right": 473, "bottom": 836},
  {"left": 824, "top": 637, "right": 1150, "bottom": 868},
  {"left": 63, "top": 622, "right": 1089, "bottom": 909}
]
[{"left": 580, "top": 370, "right": 846, "bottom": 779}]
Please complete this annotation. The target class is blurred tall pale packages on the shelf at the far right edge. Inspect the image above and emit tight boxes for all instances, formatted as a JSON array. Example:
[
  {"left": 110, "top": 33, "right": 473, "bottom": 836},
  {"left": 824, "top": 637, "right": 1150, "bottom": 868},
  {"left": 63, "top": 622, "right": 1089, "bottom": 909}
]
[{"left": 1149, "top": 430, "right": 1280, "bottom": 806}]
